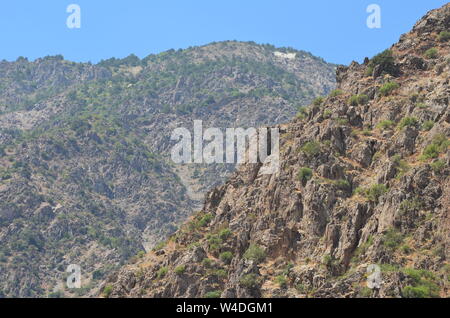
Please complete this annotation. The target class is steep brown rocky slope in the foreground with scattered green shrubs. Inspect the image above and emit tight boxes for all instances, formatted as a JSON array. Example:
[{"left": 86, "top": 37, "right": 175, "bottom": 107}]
[{"left": 101, "top": 4, "right": 450, "bottom": 297}]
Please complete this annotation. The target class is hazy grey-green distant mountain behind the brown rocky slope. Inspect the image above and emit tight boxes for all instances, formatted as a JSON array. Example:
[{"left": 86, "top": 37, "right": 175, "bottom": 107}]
[{"left": 0, "top": 41, "right": 336, "bottom": 297}]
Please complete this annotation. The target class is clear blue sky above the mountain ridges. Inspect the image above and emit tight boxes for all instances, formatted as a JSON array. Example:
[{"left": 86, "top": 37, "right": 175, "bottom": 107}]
[{"left": 0, "top": 0, "right": 448, "bottom": 64}]
